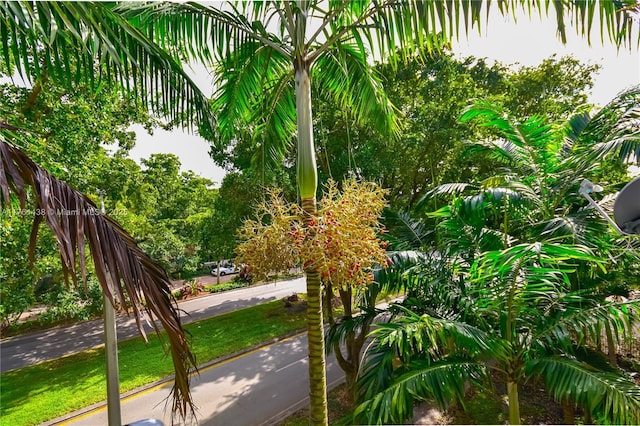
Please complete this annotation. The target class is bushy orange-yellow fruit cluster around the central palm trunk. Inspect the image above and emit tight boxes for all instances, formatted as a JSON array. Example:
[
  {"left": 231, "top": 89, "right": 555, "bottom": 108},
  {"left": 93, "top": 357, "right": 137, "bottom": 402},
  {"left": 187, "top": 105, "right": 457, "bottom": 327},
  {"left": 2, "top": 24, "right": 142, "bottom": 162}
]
[{"left": 236, "top": 179, "right": 386, "bottom": 287}]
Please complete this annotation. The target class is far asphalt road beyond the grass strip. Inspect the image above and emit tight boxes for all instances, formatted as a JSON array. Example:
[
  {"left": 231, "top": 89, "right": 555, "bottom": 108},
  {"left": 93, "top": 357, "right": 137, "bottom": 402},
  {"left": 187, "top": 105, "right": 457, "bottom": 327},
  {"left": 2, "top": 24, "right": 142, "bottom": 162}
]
[{"left": 0, "top": 278, "right": 306, "bottom": 372}]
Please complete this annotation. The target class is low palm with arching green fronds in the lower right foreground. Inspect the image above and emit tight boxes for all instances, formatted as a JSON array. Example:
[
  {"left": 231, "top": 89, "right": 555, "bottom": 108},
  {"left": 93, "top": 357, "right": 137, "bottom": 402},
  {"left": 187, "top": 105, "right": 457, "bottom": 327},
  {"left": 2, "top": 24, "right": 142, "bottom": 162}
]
[{"left": 355, "top": 243, "right": 640, "bottom": 424}]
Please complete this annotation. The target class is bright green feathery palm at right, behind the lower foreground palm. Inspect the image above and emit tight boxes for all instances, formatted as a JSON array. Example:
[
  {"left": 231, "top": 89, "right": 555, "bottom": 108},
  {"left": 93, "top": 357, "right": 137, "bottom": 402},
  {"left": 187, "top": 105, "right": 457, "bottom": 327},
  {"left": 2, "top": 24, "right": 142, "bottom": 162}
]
[{"left": 419, "top": 86, "right": 640, "bottom": 252}]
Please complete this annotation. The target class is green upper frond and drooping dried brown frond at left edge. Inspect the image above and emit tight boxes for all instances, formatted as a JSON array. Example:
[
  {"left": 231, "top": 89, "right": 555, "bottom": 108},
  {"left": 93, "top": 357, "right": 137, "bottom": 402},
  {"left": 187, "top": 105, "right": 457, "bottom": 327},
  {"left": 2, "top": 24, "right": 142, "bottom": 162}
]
[{"left": 0, "top": 1, "right": 213, "bottom": 416}]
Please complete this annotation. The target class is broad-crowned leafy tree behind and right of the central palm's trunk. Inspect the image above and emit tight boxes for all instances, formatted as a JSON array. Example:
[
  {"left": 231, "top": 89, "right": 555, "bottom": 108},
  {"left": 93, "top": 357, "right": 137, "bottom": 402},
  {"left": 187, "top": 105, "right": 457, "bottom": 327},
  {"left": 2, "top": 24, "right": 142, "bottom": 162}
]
[{"left": 315, "top": 52, "right": 597, "bottom": 209}]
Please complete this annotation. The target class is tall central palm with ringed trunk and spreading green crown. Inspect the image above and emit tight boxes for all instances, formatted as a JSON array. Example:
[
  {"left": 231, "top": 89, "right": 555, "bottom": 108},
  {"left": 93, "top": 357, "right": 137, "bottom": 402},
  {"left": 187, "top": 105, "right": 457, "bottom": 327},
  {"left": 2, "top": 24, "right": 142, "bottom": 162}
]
[{"left": 129, "top": 0, "right": 635, "bottom": 424}]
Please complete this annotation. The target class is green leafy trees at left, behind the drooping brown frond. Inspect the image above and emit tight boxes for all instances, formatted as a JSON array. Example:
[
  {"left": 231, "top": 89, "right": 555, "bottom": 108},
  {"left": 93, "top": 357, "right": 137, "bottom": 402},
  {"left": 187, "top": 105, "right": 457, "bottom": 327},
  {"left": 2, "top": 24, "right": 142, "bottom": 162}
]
[{"left": 0, "top": 82, "right": 220, "bottom": 332}]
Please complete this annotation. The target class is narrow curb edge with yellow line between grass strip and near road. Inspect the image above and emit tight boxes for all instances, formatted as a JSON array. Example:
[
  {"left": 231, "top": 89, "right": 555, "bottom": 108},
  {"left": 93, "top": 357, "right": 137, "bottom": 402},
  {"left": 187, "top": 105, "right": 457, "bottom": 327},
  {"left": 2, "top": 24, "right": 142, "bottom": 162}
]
[{"left": 41, "top": 328, "right": 307, "bottom": 426}]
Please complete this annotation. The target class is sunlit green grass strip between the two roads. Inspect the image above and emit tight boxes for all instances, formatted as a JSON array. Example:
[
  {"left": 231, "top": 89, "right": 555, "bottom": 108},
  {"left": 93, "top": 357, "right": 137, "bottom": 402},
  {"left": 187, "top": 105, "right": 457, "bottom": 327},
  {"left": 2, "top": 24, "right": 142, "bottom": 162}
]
[{"left": 0, "top": 300, "right": 305, "bottom": 426}]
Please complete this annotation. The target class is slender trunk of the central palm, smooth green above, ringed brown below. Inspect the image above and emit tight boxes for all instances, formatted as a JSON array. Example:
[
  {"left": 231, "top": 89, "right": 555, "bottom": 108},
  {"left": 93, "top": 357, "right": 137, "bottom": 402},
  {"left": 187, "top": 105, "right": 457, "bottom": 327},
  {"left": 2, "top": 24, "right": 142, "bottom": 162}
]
[{"left": 295, "top": 59, "right": 328, "bottom": 425}]
